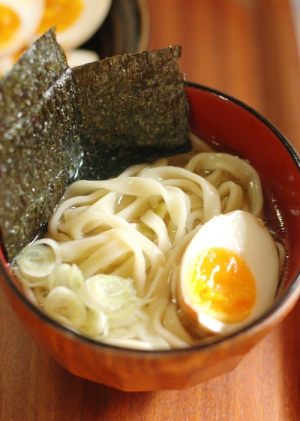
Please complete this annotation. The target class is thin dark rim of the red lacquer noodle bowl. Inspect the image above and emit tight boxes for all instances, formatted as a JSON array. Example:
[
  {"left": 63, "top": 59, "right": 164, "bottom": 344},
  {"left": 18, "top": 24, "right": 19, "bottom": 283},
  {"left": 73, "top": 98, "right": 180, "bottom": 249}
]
[{"left": 0, "top": 81, "right": 300, "bottom": 358}]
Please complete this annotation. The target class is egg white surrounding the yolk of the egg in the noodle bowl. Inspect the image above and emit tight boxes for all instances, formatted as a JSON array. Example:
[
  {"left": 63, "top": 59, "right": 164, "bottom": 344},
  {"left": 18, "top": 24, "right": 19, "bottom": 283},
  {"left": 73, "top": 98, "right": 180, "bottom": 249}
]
[{"left": 179, "top": 211, "right": 279, "bottom": 335}]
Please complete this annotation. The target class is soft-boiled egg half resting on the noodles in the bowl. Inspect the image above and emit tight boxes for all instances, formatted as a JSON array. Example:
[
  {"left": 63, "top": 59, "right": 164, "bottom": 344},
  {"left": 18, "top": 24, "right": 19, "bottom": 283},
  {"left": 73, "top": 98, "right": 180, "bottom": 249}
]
[{"left": 178, "top": 211, "right": 279, "bottom": 335}]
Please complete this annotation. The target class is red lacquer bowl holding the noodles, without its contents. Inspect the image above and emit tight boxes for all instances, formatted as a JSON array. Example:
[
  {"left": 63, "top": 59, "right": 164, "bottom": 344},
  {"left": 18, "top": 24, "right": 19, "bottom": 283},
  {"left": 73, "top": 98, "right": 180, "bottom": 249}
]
[{"left": 0, "top": 83, "right": 300, "bottom": 391}]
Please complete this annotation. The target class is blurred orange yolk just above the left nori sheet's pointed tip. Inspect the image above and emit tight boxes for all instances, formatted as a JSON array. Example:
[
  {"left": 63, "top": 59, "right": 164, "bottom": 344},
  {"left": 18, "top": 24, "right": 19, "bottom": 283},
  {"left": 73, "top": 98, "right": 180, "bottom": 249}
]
[{"left": 38, "top": 0, "right": 84, "bottom": 34}]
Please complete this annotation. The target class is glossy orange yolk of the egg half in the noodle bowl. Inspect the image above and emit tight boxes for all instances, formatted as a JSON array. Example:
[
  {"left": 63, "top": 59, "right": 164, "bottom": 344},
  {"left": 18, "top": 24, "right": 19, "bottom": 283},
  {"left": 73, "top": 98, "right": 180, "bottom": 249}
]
[{"left": 187, "top": 248, "right": 257, "bottom": 323}]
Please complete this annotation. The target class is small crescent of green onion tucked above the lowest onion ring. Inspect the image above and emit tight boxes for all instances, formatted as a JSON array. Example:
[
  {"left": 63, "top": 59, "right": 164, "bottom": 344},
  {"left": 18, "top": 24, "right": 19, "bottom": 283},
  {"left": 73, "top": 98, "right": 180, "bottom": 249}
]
[{"left": 48, "top": 263, "right": 84, "bottom": 291}]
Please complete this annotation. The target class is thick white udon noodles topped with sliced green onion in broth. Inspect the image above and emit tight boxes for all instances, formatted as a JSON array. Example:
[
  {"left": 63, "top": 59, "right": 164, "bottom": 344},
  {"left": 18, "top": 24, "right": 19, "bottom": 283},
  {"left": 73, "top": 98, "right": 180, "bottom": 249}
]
[{"left": 10, "top": 134, "right": 280, "bottom": 349}]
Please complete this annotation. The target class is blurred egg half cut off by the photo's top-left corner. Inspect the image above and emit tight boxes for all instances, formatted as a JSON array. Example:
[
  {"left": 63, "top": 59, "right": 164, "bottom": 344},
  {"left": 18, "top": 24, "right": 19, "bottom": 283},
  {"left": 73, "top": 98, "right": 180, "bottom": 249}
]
[{"left": 0, "top": 0, "right": 45, "bottom": 57}]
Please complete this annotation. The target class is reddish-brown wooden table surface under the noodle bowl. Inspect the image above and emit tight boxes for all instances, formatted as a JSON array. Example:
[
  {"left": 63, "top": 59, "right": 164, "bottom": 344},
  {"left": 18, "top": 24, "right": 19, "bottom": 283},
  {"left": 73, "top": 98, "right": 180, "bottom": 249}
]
[{"left": 0, "top": 0, "right": 300, "bottom": 421}]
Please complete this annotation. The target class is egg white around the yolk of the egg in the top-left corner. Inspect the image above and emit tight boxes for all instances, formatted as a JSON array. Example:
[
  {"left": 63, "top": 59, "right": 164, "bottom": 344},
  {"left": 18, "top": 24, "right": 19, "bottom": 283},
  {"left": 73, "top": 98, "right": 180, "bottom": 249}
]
[{"left": 0, "top": 0, "right": 45, "bottom": 57}]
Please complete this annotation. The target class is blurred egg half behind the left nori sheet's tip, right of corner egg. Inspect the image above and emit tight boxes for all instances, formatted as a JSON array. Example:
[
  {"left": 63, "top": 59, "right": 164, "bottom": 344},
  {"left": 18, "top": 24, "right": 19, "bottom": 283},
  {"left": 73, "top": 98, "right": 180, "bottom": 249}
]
[{"left": 37, "top": 0, "right": 112, "bottom": 50}]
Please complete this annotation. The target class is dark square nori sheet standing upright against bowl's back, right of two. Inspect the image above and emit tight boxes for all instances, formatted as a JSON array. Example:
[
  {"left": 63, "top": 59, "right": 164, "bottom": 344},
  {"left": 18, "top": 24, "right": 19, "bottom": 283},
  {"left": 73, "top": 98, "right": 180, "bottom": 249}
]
[{"left": 72, "top": 46, "right": 190, "bottom": 179}]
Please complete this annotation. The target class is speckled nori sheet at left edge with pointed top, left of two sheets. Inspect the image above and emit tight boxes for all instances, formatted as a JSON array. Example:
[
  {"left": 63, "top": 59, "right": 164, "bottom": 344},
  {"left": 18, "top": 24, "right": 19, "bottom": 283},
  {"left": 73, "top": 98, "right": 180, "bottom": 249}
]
[{"left": 0, "top": 30, "right": 81, "bottom": 260}]
